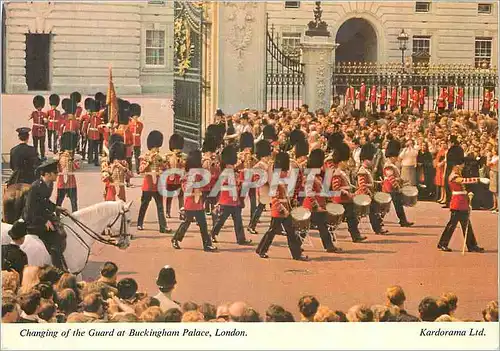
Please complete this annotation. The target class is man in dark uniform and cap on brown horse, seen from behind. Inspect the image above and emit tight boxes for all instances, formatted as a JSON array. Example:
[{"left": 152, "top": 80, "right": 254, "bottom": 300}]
[{"left": 7, "top": 128, "right": 40, "bottom": 185}]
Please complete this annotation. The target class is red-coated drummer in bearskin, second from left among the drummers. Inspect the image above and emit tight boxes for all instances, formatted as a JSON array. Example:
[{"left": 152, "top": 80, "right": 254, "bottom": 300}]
[{"left": 303, "top": 149, "right": 342, "bottom": 252}]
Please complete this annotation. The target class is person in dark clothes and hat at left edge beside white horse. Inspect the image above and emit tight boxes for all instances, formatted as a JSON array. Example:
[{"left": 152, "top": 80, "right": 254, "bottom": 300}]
[{"left": 2, "top": 219, "right": 28, "bottom": 281}]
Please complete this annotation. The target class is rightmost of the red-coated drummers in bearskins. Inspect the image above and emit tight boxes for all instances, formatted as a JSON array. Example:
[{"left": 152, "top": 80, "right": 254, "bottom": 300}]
[{"left": 382, "top": 139, "right": 413, "bottom": 227}]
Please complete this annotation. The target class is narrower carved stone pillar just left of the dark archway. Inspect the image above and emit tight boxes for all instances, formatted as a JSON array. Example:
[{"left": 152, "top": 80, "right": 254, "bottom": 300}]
[{"left": 300, "top": 35, "right": 335, "bottom": 111}]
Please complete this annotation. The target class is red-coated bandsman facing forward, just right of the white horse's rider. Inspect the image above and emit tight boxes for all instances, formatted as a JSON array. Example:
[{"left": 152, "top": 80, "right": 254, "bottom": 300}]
[{"left": 54, "top": 132, "right": 81, "bottom": 212}]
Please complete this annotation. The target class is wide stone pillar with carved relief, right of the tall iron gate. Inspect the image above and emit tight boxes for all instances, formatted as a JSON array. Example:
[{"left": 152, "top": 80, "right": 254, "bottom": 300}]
[{"left": 217, "top": 1, "right": 267, "bottom": 113}]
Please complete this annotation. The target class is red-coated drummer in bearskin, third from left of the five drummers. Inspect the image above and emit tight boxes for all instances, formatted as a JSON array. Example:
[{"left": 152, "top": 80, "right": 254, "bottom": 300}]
[{"left": 332, "top": 141, "right": 366, "bottom": 243}]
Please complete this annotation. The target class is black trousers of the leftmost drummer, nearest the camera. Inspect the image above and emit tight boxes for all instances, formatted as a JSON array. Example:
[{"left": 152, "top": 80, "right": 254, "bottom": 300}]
[{"left": 255, "top": 216, "right": 302, "bottom": 258}]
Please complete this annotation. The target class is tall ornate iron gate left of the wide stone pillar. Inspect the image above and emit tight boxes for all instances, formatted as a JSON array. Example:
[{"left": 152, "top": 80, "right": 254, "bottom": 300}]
[{"left": 173, "top": 1, "right": 205, "bottom": 150}]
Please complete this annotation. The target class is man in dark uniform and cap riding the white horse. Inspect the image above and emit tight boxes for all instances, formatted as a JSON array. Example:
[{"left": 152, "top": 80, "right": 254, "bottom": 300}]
[{"left": 23, "top": 159, "right": 67, "bottom": 269}]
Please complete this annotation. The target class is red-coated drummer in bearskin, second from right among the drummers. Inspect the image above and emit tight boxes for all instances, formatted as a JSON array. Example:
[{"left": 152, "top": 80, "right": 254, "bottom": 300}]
[{"left": 356, "top": 143, "right": 389, "bottom": 234}]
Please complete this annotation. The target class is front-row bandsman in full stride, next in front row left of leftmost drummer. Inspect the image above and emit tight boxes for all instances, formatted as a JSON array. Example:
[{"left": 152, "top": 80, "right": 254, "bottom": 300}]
[{"left": 211, "top": 145, "right": 252, "bottom": 245}]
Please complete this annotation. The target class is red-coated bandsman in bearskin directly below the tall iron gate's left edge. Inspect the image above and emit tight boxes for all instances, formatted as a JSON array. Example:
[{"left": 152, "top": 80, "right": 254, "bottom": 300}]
[{"left": 165, "top": 133, "right": 186, "bottom": 218}]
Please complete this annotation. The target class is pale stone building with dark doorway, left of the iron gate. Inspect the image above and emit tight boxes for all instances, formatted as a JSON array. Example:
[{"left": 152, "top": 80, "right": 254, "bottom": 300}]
[{"left": 2, "top": 1, "right": 173, "bottom": 95}]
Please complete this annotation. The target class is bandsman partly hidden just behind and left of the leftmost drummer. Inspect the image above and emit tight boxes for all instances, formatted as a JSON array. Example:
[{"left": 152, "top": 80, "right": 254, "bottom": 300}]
[{"left": 247, "top": 140, "right": 273, "bottom": 234}]
